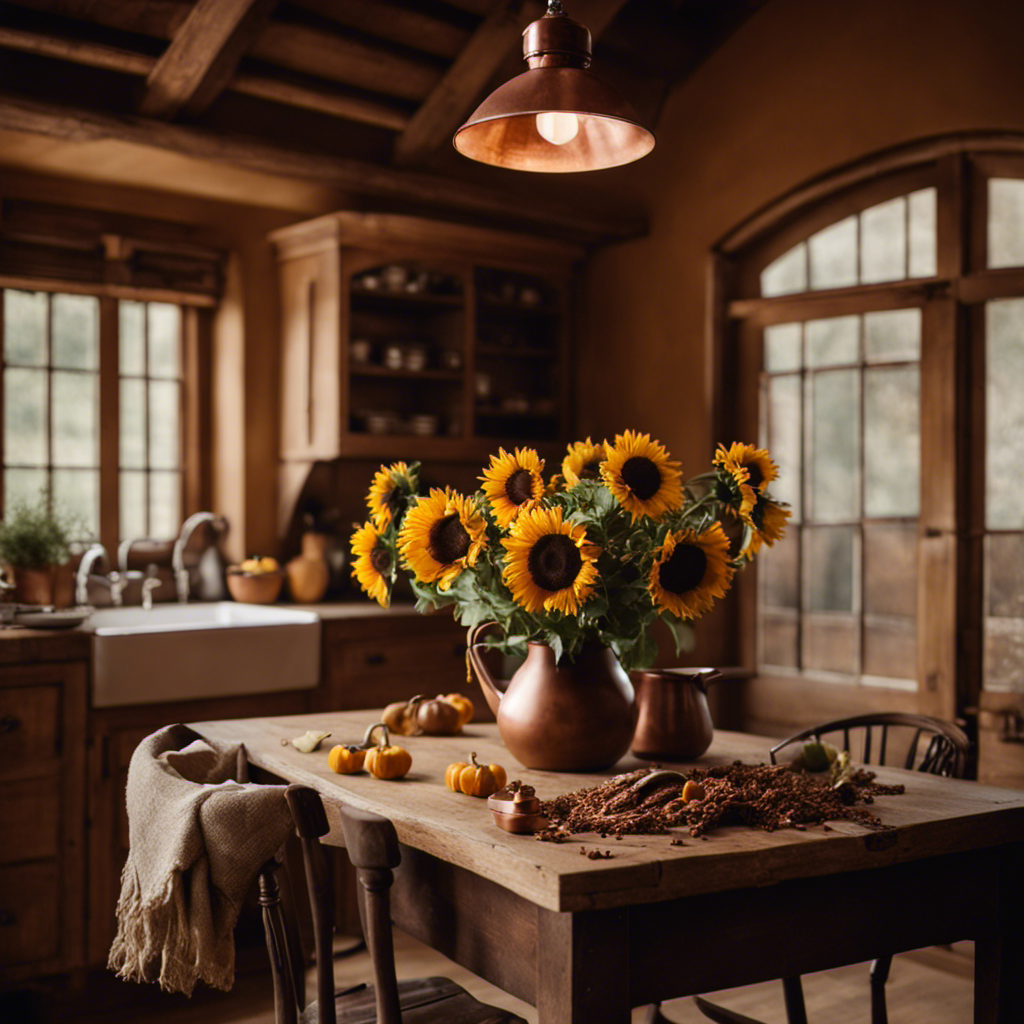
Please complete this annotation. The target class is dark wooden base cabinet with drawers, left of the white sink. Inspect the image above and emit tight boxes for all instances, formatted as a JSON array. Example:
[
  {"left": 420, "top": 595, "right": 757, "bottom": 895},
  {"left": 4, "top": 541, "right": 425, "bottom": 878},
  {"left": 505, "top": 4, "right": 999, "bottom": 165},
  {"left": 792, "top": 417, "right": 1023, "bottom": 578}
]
[{"left": 0, "top": 662, "right": 88, "bottom": 981}]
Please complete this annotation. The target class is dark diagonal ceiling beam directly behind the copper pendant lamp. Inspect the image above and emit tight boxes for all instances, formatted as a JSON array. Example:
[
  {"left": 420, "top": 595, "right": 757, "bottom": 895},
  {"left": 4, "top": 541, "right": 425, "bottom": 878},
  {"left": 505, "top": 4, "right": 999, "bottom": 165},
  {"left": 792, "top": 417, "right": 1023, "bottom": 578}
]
[{"left": 394, "top": 0, "right": 628, "bottom": 167}]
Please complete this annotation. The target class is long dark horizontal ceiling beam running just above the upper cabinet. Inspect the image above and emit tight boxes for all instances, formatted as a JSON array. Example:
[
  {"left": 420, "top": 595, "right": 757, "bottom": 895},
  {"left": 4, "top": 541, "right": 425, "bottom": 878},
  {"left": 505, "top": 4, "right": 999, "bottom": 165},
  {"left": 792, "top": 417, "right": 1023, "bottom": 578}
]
[{"left": 0, "top": 94, "right": 647, "bottom": 244}]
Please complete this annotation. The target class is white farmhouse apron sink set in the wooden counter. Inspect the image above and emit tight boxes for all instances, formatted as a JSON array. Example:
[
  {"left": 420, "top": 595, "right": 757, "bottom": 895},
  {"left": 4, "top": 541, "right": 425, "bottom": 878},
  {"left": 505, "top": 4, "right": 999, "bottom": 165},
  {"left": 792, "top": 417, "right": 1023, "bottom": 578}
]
[{"left": 82, "top": 601, "right": 321, "bottom": 708}]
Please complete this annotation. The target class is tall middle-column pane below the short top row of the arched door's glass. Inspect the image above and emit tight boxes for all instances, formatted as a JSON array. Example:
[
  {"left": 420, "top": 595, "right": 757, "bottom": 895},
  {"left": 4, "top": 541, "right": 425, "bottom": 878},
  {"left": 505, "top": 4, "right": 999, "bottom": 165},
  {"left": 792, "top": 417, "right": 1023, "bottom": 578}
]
[{"left": 807, "top": 370, "right": 860, "bottom": 521}]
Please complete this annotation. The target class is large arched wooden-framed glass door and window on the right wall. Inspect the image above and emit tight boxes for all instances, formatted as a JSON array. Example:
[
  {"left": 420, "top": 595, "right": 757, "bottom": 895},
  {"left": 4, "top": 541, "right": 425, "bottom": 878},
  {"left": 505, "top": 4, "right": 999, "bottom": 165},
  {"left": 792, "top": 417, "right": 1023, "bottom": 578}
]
[{"left": 713, "top": 135, "right": 1024, "bottom": 745}]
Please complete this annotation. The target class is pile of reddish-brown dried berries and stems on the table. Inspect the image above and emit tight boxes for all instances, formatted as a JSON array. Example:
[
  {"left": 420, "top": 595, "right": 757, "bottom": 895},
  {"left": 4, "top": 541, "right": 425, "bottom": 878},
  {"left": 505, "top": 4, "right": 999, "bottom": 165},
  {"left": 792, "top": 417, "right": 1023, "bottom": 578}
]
[{"left": 537, "top": 761, "right": 904, "bottom": 843}]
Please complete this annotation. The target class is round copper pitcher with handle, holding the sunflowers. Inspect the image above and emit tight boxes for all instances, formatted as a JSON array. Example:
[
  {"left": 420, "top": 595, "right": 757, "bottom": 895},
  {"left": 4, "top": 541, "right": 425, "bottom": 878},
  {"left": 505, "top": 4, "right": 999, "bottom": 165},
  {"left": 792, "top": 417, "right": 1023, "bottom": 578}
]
[{"left": 469, "top": 630, "right": 637, "bottom": 771}]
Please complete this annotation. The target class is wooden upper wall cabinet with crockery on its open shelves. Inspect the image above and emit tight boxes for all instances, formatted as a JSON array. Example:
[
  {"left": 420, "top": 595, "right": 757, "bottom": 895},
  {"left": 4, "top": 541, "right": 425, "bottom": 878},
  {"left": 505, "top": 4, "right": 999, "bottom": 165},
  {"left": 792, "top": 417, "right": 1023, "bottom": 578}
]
[{"left": 271, "top": 213, "right": 584, "bottom": 461}]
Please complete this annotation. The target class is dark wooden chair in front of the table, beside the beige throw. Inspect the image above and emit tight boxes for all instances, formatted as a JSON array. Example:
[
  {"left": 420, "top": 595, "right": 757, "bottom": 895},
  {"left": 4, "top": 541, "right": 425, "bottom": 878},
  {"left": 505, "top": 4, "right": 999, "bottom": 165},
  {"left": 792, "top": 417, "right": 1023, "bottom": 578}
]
[{"left": 260, "top": 785, "right": 525, "bottom": 1024}]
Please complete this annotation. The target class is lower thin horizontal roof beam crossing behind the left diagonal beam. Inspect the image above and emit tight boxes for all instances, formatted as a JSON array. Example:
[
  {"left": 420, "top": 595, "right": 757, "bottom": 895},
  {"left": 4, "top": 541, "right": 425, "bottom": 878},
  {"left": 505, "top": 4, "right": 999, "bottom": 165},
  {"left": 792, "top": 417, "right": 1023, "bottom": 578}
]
[{"left": 0, "top": 26, "right": 410, "bottom": 131}]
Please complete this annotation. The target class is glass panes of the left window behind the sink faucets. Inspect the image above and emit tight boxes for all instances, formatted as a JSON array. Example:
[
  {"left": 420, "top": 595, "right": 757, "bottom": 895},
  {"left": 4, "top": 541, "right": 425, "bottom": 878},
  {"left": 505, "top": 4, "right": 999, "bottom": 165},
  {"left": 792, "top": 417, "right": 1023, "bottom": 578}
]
[{"left": 0, "top": 288, "right": 183, "bottom": 545}]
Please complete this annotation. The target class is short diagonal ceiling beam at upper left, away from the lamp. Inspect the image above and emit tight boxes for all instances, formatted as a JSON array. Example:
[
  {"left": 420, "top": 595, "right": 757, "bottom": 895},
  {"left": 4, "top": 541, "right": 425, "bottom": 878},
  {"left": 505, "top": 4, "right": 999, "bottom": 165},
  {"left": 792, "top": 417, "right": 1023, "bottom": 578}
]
[{"left": 137, "top": 0, "right": 276, "bottom": 120}]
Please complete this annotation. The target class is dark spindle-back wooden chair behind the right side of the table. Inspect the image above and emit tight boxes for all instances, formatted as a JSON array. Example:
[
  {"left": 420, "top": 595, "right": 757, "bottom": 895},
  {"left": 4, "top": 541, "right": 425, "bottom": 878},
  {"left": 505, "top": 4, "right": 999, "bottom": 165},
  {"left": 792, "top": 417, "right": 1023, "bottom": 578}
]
[{"left": 659, "top": 712, "right": 971, "bottom": 1024}]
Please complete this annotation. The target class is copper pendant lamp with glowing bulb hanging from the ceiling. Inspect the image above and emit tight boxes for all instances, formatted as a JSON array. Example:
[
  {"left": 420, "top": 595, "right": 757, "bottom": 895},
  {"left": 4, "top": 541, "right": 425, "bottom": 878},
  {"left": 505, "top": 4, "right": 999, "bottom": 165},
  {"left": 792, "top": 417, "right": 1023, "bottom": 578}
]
[{"left": 453, "top": 0, "right": 654, "bottom": 173}]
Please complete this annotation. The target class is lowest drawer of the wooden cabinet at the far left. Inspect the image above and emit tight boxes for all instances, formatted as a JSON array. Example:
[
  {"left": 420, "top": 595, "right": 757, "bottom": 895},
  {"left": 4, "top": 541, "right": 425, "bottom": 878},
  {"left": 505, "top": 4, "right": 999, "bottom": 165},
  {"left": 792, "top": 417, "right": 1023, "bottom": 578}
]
[{"left": 0, "top": 860, "right": 60, "bottom": 965}]
